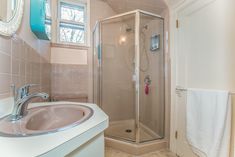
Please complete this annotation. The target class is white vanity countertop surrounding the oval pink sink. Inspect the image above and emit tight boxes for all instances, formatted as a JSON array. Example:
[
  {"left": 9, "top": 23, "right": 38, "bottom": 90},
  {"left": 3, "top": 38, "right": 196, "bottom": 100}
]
[{"left": 0, "top": 102, "right": 108, "bottom": 157}]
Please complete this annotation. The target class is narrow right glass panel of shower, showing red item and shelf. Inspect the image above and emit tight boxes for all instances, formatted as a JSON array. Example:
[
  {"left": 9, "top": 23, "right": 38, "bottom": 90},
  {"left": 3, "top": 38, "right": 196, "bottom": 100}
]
[{"left": 139, "top": 13, "right": 165, "bottom": 142}]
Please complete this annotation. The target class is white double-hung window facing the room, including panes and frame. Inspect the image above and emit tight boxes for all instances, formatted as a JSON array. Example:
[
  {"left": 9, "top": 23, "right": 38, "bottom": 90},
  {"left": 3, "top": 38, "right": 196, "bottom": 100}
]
[{"left": 57, "top": 0, "right": 86, "bottom": 45}]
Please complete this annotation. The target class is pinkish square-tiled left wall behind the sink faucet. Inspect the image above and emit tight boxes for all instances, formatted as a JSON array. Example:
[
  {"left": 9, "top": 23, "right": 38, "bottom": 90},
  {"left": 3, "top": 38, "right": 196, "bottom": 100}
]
[{"left": 0, "top": 36, "right": 51, "bottom": 99}]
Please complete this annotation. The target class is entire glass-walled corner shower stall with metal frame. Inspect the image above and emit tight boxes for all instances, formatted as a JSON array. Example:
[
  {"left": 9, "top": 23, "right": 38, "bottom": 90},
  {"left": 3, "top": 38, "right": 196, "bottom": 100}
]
[{"left": 93, "top": 10, "right": 165, "bottom": 143}]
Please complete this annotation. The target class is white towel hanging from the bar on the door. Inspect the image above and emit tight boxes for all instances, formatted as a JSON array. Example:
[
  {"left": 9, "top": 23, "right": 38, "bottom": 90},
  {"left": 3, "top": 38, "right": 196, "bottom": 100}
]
[{"left": 186, "top": 89, "right": 231, "bottom": 157}]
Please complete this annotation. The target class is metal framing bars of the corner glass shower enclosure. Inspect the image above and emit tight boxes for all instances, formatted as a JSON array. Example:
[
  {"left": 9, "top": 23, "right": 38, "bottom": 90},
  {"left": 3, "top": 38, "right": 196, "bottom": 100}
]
[{"left": 92, "top": 9, "right": 166, "bottom": 144}]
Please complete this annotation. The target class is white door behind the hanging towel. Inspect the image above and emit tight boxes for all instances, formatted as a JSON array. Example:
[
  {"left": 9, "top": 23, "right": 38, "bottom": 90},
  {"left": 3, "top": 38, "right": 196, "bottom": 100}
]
[{"left": 173, "top": 0, "right": 229, "bottom": 157}]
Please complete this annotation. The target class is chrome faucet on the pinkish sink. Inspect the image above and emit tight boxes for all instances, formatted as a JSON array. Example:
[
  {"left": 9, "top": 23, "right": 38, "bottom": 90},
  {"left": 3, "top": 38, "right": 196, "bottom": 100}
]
[{"left": 10, "top": 84, "right": 49, "bottom": 121}]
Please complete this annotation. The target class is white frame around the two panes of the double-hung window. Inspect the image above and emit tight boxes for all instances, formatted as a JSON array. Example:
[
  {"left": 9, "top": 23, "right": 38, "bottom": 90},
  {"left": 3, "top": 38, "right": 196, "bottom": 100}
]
[{"left": 56, "top": 0, "right": 88, "bottom": 47}]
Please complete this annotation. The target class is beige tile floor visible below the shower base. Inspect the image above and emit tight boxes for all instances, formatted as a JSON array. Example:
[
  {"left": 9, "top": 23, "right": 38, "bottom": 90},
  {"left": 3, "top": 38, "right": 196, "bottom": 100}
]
[{"left": 105, "top": 147, "right": 176, "bottom": 157}]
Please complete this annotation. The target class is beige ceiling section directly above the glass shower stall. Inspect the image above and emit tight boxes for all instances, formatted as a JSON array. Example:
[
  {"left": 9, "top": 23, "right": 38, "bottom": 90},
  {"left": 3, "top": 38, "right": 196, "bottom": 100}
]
[{"left": 103, "top": 0, "right": 168, "bottom": 14}]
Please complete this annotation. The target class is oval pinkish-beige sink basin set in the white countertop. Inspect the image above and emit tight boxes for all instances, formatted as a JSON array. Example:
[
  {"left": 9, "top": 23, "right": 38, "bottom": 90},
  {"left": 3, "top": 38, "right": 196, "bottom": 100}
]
[{"left": 0, "top": 104, "right": 93, "bottom": 137}]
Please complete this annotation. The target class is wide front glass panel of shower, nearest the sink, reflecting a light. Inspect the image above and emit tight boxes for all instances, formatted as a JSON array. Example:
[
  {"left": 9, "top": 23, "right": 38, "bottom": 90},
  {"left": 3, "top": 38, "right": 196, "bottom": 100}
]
[{"left": 101, "top": 14, "right": 136, "bottom": 142}]
